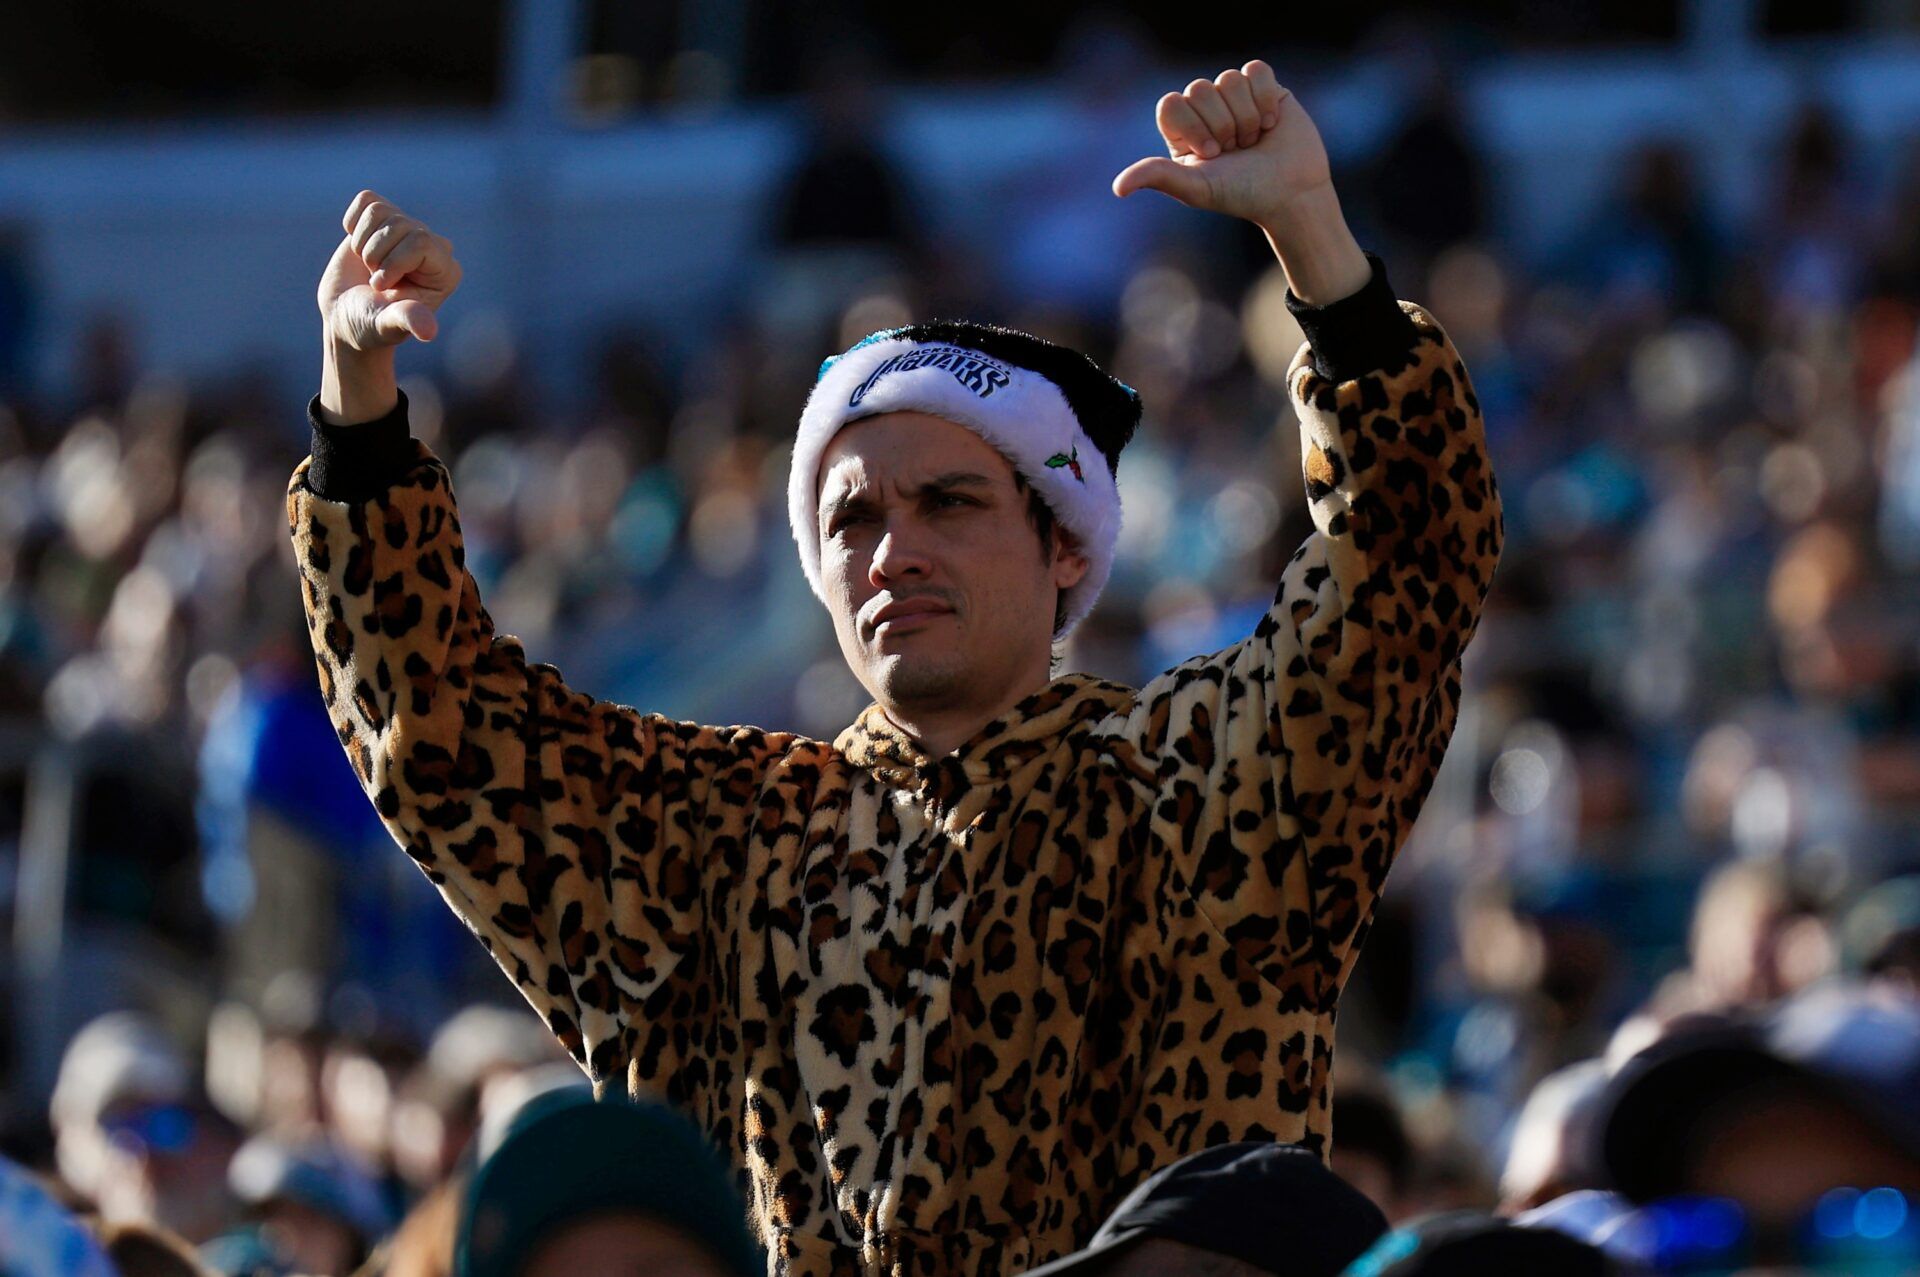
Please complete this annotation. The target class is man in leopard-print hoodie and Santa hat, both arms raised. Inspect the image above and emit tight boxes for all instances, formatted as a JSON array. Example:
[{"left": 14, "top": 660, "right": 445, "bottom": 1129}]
[{"left": 288, "top": 61, "right": 1500, "bottom": 1273}]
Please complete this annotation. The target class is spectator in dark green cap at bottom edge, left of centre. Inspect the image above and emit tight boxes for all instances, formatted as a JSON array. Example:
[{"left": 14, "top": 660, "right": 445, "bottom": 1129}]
[{"left": 453, "top": 1089, "right": 766, "bottom": 1277}]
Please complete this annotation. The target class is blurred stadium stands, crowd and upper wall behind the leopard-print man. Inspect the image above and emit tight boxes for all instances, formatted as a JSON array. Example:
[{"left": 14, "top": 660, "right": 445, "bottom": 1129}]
[{"left": 0, "top": 0, "right": 1920, "bottom": 1271}]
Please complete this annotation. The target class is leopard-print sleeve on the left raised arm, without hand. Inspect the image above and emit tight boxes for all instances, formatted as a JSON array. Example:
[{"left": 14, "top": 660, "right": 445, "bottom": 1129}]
[{"left": 288, "top": 432, "right": 791, "bottom": 1100}]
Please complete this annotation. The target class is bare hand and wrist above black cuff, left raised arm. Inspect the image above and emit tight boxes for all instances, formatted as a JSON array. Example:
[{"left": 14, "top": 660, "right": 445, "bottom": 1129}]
[{"left": 319, "top": 190, "right": 461, "bottom": 424}]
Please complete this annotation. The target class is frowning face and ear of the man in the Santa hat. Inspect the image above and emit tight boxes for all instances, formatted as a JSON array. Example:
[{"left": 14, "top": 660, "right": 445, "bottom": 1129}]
[{"left": 818, "top": 413, "right": 1087, "bottom": 716}]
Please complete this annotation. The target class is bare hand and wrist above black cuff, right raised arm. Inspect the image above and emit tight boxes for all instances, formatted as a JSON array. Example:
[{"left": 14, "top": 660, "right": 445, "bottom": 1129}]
[{"left": 1114, "top": 58, "right": 1373, "bottom": 305}]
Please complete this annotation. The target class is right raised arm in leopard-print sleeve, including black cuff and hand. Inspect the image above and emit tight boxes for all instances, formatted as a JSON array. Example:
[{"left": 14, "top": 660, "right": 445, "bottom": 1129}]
[{"left": 1114, "top": 61, "right": 1501, "bottom": 983}]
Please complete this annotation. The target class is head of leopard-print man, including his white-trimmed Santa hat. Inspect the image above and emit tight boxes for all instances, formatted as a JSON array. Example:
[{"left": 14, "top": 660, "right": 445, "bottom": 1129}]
[{"left": 787, "top": 323, "right": 1140, "bottom": 725}]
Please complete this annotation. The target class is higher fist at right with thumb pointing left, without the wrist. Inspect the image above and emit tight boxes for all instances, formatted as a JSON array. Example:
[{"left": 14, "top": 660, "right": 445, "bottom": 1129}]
[{"left": 1114, "top": 58, "right": 1332, "bottom": 229}]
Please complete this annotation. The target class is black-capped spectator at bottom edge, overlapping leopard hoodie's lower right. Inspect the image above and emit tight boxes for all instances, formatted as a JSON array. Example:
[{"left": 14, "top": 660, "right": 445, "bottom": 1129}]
[{"left": 1033, "top": 1144, "right": 1386, "bottom": 1277}]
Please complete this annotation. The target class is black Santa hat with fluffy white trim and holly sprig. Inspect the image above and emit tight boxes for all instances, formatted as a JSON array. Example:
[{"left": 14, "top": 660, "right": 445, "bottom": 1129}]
[{"left": 787, "top": 321, "right": 1140, "bottom": 638}]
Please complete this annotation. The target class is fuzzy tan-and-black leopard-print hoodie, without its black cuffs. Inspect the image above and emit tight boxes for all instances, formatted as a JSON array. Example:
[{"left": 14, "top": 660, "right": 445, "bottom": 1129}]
[{"left": 288, "top": 303, "right": 1501, "bottom": 1275}]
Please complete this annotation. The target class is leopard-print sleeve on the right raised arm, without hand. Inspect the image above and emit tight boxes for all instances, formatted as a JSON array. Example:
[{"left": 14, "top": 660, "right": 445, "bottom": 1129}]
[{"left": 1121, "top": 275, "right": 1501, "bottom": 1004}]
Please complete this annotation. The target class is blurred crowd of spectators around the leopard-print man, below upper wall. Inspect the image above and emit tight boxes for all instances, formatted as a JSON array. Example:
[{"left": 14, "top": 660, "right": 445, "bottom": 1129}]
[{"left": 0, "top": 34, "right": 1920, "bottom": 1277}]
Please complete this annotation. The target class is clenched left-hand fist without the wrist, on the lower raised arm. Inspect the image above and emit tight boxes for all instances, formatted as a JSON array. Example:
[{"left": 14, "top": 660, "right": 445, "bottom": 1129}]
[{"left": 319, "top": 190, "right": 461, "bottom": 349}]
